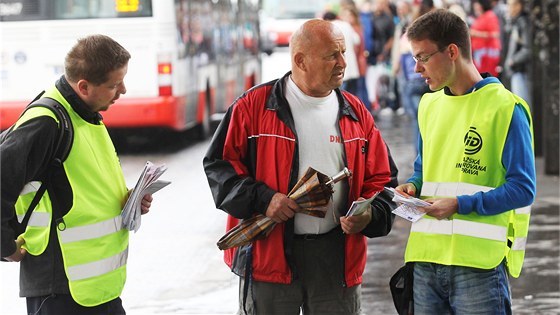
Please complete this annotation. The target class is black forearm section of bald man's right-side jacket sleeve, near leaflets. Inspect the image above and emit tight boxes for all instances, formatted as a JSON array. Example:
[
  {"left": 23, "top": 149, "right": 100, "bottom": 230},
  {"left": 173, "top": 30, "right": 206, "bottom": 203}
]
[{"left": 362, "top": 142, "right": 399, "bottom": 238}]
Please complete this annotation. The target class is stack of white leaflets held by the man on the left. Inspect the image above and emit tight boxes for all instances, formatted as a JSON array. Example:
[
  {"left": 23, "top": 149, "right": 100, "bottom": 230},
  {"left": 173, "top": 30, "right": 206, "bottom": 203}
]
[{"left": 121, "top": 161, "right": 171, "bottom": 232}]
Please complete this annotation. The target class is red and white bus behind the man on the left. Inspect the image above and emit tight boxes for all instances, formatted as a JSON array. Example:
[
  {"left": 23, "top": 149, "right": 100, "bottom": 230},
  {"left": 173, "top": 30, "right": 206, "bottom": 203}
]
[{"left": 0, "top": 0, "right": 261, "bottom": 137}]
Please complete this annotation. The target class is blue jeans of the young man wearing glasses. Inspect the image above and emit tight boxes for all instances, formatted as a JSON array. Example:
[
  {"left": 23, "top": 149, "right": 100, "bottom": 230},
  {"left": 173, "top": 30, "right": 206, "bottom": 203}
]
[{"left": 413, "top": 262, "right": 511, "bottom": 315}]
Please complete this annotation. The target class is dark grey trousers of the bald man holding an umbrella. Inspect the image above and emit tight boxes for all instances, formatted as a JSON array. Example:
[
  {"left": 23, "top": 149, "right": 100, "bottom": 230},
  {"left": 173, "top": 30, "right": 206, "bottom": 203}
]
[{"left": 238, "top": 229, "right": 361, "bottom": 315}]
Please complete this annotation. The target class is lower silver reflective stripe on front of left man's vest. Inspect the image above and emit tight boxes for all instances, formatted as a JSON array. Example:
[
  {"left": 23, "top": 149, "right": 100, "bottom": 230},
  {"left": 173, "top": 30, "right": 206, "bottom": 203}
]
[{"left": 68, "top": 247, "right": 128, "bottom": 281}]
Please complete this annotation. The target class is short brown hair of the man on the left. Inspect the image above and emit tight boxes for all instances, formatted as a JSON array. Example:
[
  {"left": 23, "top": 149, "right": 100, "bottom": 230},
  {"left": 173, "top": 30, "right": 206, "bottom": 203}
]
[{"left": 64, "top": 35, "right": 130, "bottom": 85}]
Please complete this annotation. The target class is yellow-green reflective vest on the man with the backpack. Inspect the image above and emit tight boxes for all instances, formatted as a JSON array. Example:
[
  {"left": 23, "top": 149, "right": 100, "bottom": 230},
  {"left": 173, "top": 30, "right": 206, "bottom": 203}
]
[{"left": 16, "top": 88, "right": 128, "bottom": 306}]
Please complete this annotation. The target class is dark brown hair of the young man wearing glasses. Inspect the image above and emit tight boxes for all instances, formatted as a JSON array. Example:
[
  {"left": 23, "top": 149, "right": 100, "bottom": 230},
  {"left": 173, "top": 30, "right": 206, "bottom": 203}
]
[{"left": 406, "top": 9, "right": 471, "bottom": 60}]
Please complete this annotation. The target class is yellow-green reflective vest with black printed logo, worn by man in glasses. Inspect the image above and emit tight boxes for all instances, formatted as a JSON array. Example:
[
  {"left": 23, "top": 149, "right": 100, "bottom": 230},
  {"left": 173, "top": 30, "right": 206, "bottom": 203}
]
[{"left": 405, "top": 83, "right": 532, "bottom": 277}]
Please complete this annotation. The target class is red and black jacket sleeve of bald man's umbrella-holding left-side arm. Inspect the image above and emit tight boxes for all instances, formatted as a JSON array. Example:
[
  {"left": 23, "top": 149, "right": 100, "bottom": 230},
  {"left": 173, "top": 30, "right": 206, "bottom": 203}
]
[{"left": 203, "top": 98, "right": 276, "bottom": 219}]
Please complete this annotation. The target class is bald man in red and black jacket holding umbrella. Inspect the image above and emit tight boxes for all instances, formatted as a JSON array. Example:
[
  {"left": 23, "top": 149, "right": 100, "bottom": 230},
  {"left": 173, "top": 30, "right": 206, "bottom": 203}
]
[{"left": 203, "top": 19, "right": 397, "bottom": 315}]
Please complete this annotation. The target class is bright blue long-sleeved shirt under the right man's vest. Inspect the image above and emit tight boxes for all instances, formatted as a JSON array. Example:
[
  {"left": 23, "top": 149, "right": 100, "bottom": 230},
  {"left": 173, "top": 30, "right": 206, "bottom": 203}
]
[{"left": 407, "top": 77, "right": 537, "bottom": 215}]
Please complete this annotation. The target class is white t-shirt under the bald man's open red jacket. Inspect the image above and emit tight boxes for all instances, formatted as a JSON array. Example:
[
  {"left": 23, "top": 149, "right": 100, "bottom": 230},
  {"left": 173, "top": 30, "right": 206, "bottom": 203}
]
[{"left": 284, "top": 76, "right": 348, "bottom": 234}]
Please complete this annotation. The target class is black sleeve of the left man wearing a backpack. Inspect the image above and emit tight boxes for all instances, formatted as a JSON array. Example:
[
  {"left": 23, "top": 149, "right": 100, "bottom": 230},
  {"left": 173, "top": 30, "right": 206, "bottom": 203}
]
[{"left": 0, "top": 116, "right": 58, "bottom": 257}]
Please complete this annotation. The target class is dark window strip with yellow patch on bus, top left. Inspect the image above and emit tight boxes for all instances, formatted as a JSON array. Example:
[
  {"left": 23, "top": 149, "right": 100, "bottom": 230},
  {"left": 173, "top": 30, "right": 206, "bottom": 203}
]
[{"left": 0, "top": 0, "right": 152, "bottom": 22}]
